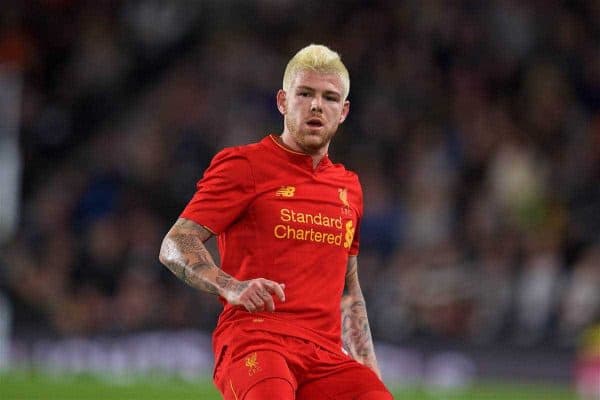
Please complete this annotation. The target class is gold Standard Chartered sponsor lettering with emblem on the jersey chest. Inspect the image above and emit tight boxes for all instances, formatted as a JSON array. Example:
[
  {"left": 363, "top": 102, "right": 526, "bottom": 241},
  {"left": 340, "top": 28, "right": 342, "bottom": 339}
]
[{"left": 273, "top": 208, "right": 354, "bottom": 249}]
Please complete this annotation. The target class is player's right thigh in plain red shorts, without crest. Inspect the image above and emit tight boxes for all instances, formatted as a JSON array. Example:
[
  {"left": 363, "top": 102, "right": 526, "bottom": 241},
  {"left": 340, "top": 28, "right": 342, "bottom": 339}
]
[{"left": 296, "top": 363, "right": 393, "bottom": 400}]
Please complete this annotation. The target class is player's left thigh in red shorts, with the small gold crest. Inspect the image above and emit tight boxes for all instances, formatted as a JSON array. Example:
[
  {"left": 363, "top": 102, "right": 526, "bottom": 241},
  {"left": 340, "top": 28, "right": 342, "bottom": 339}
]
[{"left": 215, "top": 350, "right": 297, "bottom": 400}]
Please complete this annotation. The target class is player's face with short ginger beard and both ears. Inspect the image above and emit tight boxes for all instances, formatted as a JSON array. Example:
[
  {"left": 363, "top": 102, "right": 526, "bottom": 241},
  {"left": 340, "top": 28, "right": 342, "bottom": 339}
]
[{"left": 277, "top": 70, "right": 350, "bottom": 154}]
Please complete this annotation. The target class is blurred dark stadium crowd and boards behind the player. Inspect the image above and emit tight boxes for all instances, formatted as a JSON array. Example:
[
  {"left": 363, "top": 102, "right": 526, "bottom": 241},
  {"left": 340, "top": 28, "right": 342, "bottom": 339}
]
[{"left": 0, "top": 0, "right": 600, "bottom": 400}]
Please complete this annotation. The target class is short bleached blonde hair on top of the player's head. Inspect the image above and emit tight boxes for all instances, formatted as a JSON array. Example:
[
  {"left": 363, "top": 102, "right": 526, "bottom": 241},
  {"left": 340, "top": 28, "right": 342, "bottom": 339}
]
[{"left": 283, "top": 44, "right": 350, "bottom": 100}]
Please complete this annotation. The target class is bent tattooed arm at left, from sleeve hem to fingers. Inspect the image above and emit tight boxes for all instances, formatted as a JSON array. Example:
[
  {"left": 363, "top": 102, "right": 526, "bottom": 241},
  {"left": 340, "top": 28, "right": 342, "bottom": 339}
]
[{"left": 159, "top": 218, "right": 285, "bottom": 312}]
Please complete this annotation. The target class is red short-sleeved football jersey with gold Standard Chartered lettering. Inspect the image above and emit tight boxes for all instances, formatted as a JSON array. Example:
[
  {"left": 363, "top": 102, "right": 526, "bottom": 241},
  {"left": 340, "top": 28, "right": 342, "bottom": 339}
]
[{"left": 181, "top": 135, "right": 363, "bottom": 355}]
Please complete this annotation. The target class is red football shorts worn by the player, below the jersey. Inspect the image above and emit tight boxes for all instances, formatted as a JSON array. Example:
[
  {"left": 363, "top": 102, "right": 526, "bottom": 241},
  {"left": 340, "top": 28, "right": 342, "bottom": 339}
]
[{"left": 214, "top": 331, "right": 392, "bottom": 400}]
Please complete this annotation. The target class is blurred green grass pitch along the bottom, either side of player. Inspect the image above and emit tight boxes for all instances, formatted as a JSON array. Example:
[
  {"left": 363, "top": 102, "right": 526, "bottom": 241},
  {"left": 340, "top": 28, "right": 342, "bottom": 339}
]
[{"left": 0, "top": 372, "right": 577, "bottom": 400}]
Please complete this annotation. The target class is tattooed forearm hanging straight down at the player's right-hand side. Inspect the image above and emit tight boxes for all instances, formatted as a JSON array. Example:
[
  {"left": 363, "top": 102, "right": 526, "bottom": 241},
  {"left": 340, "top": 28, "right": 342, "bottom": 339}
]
[{"left": 341, "top": 256, "right": 381, "bottom": 379}]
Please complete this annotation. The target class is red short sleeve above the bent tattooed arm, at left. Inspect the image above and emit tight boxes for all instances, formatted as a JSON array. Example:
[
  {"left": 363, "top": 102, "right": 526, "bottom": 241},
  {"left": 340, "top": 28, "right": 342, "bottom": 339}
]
[{"left": 180, "top": 147, "right": 255, "bottom": 235}]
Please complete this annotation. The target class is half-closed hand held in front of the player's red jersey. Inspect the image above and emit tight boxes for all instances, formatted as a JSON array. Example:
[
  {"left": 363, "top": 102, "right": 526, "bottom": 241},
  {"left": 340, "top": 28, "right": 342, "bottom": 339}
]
[{"left": 224, "top": 278, "right": 285, "bottom": 312}]
